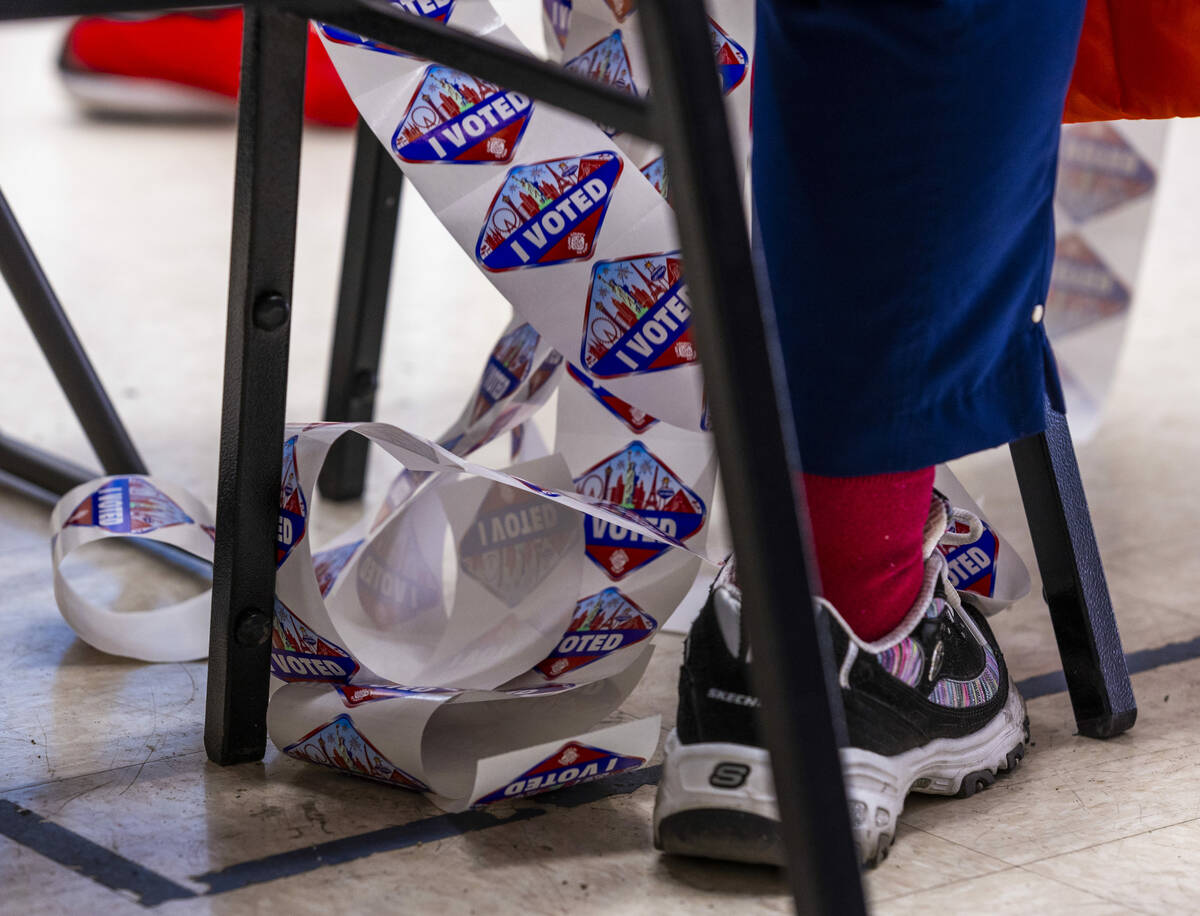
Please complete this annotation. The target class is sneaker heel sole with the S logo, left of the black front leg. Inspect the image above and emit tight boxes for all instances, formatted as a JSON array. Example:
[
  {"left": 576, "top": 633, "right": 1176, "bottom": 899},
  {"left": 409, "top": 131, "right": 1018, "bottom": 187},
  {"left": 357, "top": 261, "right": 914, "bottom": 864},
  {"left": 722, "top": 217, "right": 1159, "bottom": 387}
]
[{"left": 654, "top": 731, "right": 785, "bottom": 866}]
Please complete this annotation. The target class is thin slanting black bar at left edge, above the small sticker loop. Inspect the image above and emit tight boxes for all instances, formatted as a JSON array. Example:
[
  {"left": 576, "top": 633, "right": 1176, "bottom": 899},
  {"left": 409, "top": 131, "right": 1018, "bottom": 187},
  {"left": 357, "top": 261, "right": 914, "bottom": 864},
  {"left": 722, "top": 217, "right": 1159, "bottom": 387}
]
[{"left": 0, "top": 184, "right": 146, "bottom": 475}]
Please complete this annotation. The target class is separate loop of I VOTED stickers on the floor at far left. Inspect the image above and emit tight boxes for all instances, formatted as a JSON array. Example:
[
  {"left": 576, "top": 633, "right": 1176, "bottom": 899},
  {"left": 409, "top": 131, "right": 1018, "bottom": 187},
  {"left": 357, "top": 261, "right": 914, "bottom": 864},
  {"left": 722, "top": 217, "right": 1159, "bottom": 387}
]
[{"left": 50, "top": 475, "right": 214, "bottom": 661}]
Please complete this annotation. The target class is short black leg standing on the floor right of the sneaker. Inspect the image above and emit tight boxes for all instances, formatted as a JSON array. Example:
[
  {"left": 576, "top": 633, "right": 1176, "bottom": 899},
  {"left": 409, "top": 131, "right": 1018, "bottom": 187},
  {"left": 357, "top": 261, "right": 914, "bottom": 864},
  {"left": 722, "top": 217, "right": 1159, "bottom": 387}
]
[{"left": 1010, "top": 405, "right": 1138, "bottom": 738}]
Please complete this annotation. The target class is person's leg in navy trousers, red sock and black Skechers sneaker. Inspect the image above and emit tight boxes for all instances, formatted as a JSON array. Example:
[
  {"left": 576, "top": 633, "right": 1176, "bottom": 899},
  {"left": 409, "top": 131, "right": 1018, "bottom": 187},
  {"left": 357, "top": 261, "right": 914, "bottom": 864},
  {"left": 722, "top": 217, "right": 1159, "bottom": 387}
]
[{"left": 655, "top": 0, "right": 1084, "bottom": 862}]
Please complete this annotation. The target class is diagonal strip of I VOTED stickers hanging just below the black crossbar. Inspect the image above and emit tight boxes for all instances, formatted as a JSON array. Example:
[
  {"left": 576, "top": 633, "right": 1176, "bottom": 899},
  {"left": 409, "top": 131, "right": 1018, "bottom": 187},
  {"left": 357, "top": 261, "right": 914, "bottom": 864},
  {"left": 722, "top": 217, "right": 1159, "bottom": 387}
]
[{"left": 322, "top": 0, "right": 702, "bottom": 429}]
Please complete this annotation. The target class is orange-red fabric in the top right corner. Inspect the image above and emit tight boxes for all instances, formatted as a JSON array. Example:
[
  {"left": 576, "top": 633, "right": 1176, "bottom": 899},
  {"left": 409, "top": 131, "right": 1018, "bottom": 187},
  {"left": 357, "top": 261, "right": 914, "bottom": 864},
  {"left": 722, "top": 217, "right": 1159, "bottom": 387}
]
[{"left": 1063, "top": 0, "right": 1200, "bottom": 122}]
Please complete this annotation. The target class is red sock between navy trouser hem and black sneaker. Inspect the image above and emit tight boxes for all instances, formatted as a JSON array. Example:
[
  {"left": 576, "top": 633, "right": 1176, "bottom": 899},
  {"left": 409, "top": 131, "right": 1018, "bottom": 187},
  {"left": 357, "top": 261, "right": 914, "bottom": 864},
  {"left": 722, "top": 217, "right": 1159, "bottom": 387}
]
[{"left": 804, "top": 467, "right": 934, "bottom": 641}]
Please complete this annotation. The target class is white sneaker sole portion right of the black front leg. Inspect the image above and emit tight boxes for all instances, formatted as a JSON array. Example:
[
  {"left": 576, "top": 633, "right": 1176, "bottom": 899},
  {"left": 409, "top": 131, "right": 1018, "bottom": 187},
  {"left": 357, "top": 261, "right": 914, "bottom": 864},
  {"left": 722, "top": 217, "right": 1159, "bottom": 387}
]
[{"left": 841, "top": 682, "right": 1030, "bottom": 867}]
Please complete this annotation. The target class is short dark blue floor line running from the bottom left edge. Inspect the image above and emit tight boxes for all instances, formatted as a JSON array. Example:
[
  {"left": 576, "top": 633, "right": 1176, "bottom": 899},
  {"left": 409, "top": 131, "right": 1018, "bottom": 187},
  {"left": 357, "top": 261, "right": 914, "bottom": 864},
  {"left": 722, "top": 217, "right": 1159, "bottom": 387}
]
[{"left": 0, "top": 798, "right": 197, "bottom": 906}]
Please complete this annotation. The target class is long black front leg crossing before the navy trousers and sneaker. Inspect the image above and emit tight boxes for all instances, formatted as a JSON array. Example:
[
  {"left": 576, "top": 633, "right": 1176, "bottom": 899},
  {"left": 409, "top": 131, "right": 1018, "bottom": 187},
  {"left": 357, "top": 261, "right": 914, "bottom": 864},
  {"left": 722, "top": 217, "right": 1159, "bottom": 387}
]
[{"left": 641, "top": 0, "right": 865, "bottom": 914}]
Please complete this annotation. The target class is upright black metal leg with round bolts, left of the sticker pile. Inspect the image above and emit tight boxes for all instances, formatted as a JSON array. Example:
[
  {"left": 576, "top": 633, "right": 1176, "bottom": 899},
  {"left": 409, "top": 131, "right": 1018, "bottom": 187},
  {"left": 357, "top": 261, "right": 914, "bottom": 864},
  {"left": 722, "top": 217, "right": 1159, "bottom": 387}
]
[{"left": 204, "top": 6, "right": 308, "bottom": 764}]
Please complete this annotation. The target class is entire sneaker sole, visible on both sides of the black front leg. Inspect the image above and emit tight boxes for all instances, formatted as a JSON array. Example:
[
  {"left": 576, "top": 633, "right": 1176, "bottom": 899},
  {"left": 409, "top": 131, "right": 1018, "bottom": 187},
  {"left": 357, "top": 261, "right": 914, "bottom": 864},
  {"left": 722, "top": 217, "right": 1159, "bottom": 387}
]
[{"left": 654, "top": 682, "right": 1028, "bottom": 866}]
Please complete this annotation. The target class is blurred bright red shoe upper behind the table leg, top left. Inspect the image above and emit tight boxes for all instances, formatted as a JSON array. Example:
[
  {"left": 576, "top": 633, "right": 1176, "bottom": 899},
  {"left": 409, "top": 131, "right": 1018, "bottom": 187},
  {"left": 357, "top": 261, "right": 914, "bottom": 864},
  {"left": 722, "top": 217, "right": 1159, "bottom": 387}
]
[{"left": 67, "top": 10, "right": 358, "bottom": 127}]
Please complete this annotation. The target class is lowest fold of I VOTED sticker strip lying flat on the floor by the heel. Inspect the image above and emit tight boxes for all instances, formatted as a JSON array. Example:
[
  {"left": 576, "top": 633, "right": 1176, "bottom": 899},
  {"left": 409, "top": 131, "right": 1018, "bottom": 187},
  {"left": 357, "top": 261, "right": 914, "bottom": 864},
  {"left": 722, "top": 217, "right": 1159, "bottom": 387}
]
[{"left": 268, "top": 647, "right": 659, "bottom": 810}]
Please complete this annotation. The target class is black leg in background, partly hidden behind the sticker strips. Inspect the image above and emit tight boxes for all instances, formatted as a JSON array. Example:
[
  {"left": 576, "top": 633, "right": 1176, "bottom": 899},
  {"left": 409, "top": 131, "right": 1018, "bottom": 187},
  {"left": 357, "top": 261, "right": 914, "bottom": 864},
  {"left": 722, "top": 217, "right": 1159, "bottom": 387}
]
[{"left": 318, "top": 119, "right": 404, "bottom": 499}]
